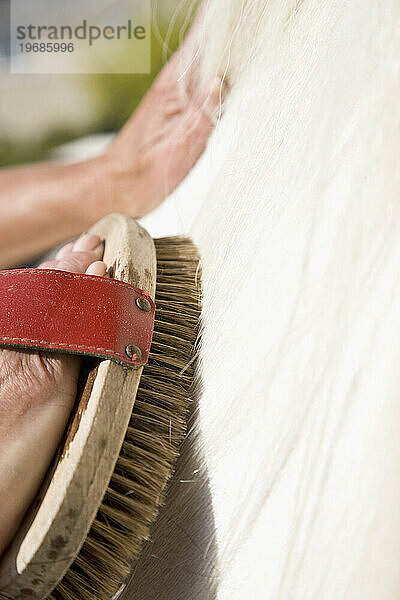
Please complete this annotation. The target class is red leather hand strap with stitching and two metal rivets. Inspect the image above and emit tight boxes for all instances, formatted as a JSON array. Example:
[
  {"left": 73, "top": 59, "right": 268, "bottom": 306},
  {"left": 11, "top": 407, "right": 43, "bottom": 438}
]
[{"left": 0, "top": 269, "right": 155, "bottom": 367}]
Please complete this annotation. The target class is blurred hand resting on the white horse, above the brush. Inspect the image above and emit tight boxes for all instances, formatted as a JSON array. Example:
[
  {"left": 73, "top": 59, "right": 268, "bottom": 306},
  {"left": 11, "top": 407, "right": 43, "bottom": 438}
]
[{"left": 101, "top": 7, "right": 224, "bottom": 218}]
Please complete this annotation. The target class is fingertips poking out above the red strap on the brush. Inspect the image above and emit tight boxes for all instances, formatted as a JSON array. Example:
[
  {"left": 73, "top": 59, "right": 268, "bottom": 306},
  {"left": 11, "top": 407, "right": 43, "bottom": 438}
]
[{"left": 39, "top": 234, "right": 107, "bottom": 277}]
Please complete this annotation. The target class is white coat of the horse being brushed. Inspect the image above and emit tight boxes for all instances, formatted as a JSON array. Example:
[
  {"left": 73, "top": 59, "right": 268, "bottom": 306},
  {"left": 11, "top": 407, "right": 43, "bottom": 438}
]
[{"left": 131, "top": 0, "right": 400, "bottom": 600}]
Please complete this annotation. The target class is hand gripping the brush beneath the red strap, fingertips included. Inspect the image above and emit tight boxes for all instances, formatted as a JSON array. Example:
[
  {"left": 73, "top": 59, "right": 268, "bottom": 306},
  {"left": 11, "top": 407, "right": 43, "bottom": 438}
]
[{"left": 0, "top": 234, "right": 106, "bottom": 556}]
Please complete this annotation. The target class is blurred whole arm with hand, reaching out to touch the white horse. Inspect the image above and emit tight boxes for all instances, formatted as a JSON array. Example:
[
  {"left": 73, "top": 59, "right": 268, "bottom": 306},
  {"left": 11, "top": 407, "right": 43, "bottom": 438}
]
[{"left": 0, "top": 26, "right": 223, "bottom": 268}]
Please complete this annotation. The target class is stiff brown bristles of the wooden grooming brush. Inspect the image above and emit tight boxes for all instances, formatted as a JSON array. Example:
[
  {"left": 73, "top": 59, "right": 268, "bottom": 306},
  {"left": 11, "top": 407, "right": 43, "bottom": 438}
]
[{"left": 48, "top": 238, "right": 200, "bottom": 600}]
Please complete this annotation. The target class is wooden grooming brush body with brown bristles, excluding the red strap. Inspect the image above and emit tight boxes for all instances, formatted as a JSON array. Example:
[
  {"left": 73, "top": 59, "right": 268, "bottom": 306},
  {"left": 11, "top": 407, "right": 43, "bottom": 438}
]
[{"left": 0, "top": 215, "right": 200, "bottom": 600}]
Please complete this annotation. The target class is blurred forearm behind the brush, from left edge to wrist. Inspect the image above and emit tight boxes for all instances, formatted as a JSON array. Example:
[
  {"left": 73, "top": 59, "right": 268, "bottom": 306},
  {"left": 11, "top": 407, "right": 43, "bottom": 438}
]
[{"left": 0, "top": 160, "right": 107, "bottom": 268}]
